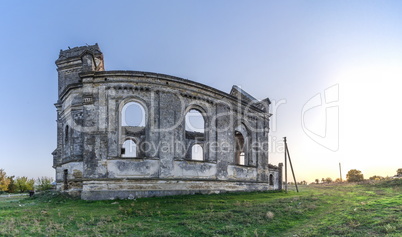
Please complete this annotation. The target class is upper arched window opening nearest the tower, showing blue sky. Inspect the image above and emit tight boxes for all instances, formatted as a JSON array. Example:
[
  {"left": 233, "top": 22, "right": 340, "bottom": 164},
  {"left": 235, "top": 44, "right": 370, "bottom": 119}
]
[{"left": 121, "top": 102, "right": 146, "bottom": 127}]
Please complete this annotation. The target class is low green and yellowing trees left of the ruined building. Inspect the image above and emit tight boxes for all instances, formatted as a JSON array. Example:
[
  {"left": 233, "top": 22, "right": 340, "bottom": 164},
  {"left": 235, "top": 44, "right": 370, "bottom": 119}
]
[{"left": 0, "top": 169, "right": 53, "bottom": 194}]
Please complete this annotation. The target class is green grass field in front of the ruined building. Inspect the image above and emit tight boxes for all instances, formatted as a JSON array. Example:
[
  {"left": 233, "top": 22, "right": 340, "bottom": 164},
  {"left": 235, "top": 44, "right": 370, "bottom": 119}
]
[{"left": 0, "top": 179, "right": 402, "bottom": 237}]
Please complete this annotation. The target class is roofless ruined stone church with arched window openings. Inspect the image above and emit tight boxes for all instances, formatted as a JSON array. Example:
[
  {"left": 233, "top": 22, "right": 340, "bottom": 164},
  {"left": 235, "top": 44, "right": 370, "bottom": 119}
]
[{"left": 52, "top": 44, "right": 282, "bottom": 200}]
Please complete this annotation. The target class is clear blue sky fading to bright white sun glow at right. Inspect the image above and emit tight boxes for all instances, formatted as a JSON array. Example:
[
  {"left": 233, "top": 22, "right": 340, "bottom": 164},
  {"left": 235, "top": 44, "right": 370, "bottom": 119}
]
[{"left": 0, "top": 0, "right": 402, "bottom": 181}]
